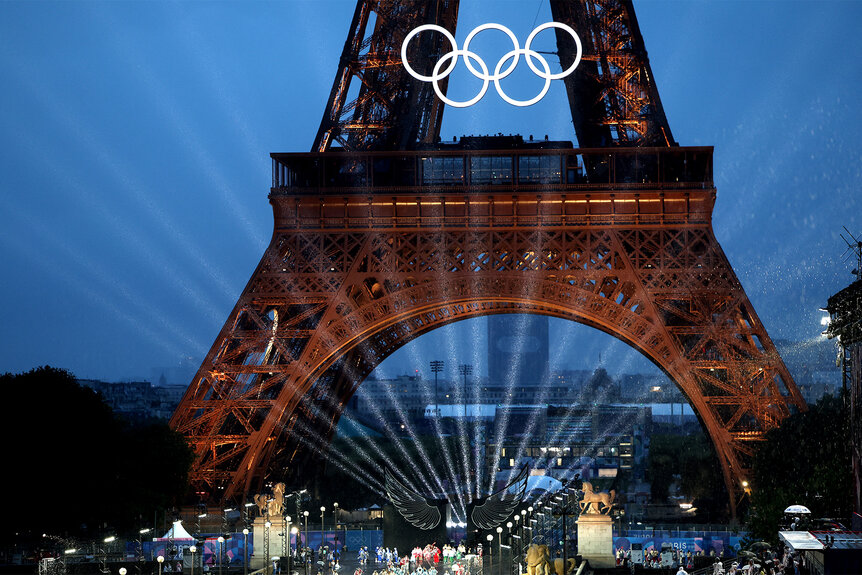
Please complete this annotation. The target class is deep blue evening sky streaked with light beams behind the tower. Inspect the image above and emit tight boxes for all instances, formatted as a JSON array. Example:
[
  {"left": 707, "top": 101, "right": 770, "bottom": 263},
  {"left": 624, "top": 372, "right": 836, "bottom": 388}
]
[{"left": 0, "top": 0, "right": 862, "bottom": 383}]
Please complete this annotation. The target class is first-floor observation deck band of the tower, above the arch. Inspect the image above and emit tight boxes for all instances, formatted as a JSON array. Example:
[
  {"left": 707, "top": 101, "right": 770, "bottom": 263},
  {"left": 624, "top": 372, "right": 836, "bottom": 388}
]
[{"left": 270, "top": 136, "right": 715, "bottom": 229}]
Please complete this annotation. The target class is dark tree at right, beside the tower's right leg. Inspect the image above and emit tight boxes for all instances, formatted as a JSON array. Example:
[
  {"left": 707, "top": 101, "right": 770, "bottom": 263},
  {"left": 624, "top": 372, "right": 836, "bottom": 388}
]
[{"left": 747, "top": 395, "right": 853, "bottom": 541}]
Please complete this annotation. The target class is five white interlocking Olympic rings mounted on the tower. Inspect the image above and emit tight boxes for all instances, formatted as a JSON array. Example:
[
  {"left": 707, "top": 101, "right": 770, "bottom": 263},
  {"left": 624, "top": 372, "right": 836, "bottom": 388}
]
[{"left": 401, "top": 22, "right": 583, "bottom": 108}]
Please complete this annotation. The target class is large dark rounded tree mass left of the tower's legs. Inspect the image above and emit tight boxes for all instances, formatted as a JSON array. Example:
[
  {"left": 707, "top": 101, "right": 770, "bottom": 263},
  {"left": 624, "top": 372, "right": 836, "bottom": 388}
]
[{"left": 0, "top": 367, "right": 192, "bottom": 538}]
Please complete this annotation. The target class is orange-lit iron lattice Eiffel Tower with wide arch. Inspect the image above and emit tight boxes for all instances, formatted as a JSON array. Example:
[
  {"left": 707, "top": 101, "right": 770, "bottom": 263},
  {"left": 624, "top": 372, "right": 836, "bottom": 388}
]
[{"left": 171, "top": 0, "right": 804, "bottom": 510}]
